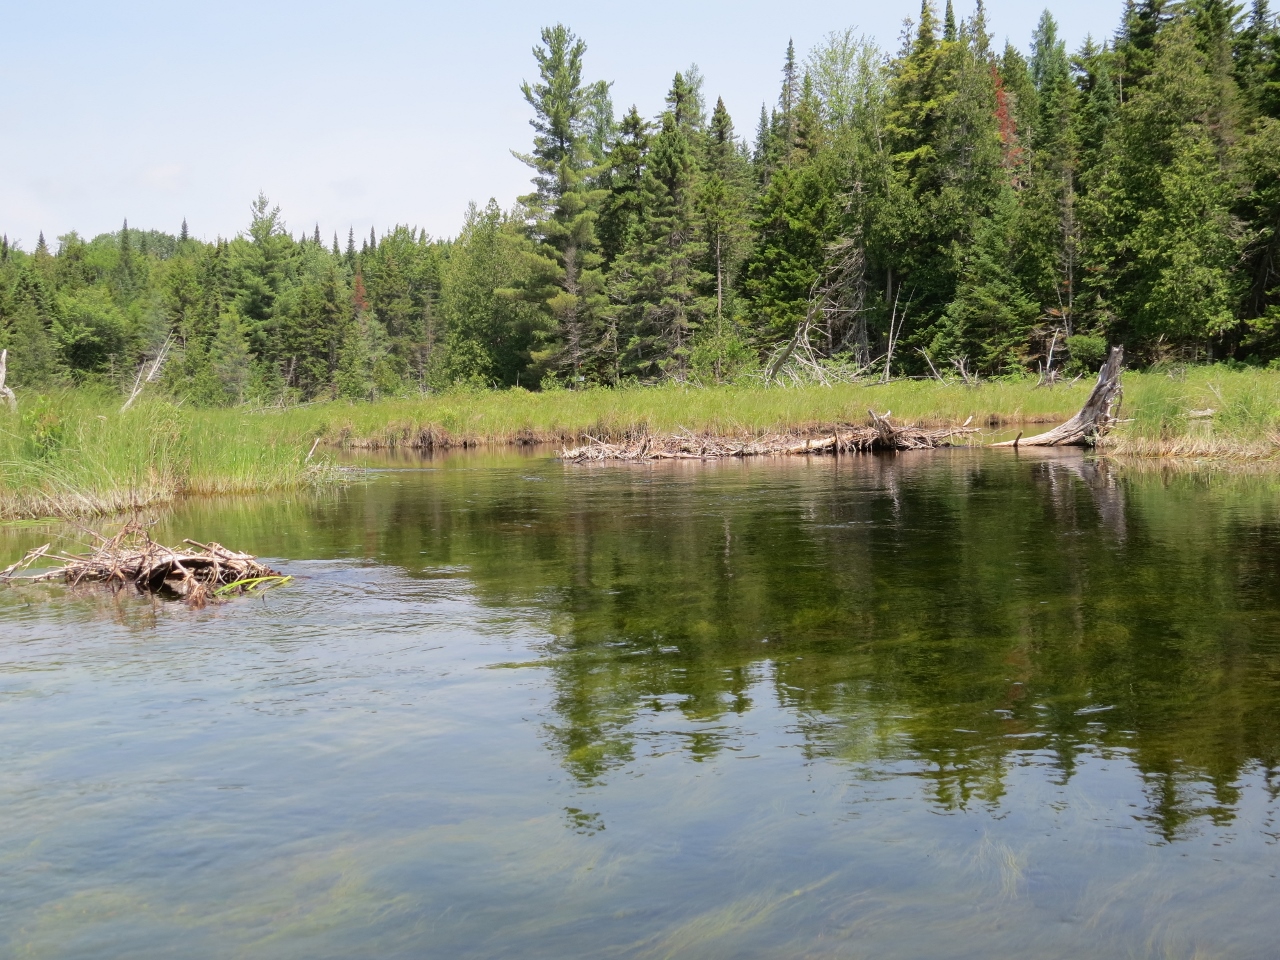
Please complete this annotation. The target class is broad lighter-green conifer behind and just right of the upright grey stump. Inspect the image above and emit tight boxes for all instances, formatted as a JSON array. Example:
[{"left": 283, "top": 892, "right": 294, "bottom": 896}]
[{"left": 1083, "top": 18, "right": 1240, "bottom": 355}]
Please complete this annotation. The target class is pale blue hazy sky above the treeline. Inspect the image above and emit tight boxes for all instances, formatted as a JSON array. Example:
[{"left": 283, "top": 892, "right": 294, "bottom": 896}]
[{"left": 0, "top": 0, "right": 1121, "bottom": 250}]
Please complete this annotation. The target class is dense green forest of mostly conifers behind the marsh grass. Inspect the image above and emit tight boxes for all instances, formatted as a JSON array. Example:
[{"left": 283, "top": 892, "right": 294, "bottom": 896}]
[{"left": 0, "top": 0, "right": 1280, "bottom": 403}]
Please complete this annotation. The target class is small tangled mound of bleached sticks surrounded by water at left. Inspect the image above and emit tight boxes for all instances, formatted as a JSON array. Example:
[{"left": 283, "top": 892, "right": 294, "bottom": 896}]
[{"left": 0, "top": 524, "right": 293, "bottom": 609}]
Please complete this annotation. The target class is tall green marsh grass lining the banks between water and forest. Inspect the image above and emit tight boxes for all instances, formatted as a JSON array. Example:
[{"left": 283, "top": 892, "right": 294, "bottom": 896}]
[{"left": 0, "top": 367, "right": 1280, "bottom": 520}]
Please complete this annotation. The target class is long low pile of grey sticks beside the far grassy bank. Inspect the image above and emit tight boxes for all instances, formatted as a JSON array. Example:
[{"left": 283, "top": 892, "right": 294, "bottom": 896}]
[{"left": 561, "top": 411, "right": 977, "bottom": 463}]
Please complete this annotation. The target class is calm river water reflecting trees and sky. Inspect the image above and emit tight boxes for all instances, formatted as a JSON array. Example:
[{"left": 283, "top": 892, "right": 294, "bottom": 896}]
[{"left": 0, "top": 451, "right": 1280, "bottom": 960}]
